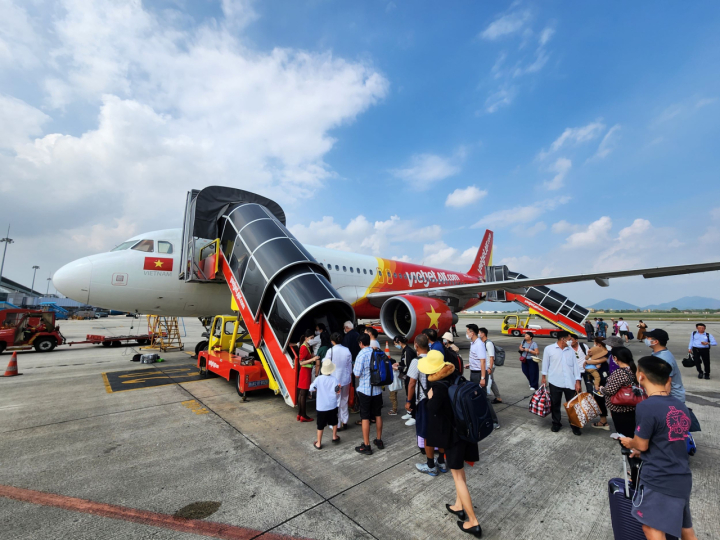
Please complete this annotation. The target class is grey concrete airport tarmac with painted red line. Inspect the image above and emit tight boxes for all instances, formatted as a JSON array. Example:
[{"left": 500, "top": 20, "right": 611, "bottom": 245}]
[{"left": 0, "top": 317, "right": 720, "bottom": 540}]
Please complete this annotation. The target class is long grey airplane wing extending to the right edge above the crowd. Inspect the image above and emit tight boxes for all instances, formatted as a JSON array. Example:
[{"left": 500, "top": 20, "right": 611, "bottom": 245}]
[{"left": 367, "top": 262, "right": 720, "bottom": 301}]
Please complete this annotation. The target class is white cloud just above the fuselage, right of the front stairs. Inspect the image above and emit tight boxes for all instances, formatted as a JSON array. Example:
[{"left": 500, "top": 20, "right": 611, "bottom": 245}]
[{"left": 290, "top": 215, "right": 442, "bottom": 257}]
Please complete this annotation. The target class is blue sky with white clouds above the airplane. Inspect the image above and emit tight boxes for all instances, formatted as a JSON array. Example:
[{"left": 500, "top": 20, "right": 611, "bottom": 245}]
[{"left": 0, "top": 0, "right": 720, "bottom": 306}]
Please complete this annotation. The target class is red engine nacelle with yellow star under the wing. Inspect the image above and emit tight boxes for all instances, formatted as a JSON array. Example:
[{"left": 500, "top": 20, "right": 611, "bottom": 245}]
[{"left": 380, "top": 294, "right": 458, "bottom": 341}]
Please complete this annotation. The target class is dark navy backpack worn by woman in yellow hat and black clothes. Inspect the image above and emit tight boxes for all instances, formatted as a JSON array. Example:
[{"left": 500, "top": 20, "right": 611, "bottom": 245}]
[{"left": 448, "top": 375, "right": 493, "bottom": 443}]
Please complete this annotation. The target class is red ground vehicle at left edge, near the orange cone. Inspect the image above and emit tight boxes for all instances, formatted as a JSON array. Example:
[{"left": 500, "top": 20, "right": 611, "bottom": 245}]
[{"left": 0, "top": 309, "right": 65, "bottom": 353}]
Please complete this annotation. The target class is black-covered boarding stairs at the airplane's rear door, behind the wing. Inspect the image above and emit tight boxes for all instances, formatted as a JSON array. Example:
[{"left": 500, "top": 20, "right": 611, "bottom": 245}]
[{"left": 485, "top": 266, "right": 590, "bottom": 336}]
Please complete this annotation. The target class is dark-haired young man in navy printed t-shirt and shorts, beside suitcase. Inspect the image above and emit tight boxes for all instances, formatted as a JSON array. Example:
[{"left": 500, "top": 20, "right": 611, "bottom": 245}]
[{"left": 620, "top": 356, "right": 697, "bottom": 540}]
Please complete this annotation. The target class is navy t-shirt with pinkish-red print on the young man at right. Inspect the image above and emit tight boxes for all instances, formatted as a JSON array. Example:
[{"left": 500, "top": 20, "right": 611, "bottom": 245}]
[{"left": 635, "top": 396, "right": 692, "bottom": 499}]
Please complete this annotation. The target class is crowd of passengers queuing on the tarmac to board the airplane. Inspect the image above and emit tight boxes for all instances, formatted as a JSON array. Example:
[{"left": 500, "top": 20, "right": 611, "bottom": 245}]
[{"left": 290, "top": 319, "right": 704, "bottom": 538}]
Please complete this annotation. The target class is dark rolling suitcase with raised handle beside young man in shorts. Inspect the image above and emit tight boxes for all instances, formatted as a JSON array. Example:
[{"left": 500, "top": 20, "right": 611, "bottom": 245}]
[{"left": 608, "top": 447, "right": 678, "bottom": 540}]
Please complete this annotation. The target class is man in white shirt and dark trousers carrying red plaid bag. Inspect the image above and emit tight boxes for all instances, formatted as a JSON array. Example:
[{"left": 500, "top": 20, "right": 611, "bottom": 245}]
[{"left": 541, "top": 330, "right": 582, "bottom": 435}]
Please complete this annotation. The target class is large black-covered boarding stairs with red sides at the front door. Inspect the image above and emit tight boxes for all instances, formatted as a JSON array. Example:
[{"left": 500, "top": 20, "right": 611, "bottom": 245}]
[{"left": 179, "top": 186, "right": 355, "bottom": 406}]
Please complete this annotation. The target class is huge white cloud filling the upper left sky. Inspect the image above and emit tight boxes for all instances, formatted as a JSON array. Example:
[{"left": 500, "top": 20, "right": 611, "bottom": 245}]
[{"left": 0, "top": 0, "right": 388, "bottom": 278}]
